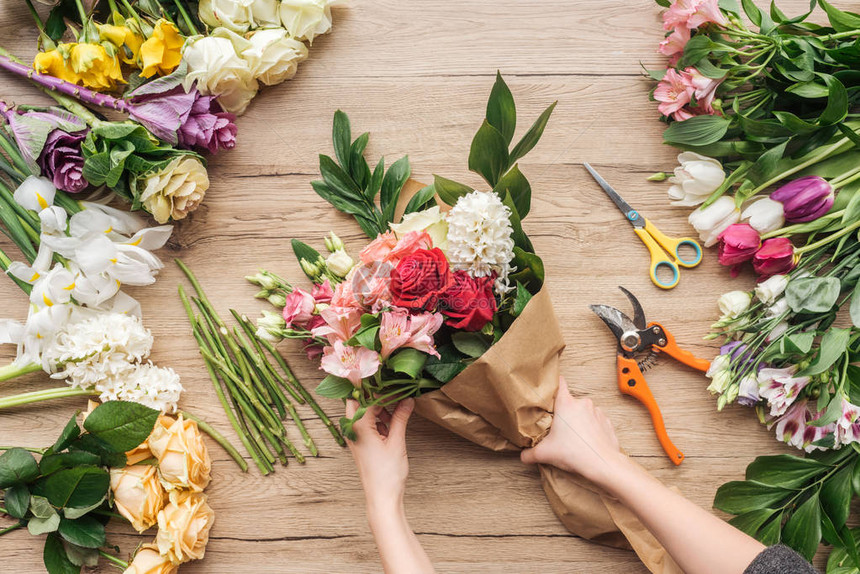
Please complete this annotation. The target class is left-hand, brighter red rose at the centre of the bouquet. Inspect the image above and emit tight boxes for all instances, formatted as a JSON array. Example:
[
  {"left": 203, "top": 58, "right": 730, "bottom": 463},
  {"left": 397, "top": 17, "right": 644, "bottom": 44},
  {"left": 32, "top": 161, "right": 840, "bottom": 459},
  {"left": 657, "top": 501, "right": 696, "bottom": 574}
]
[{"left": 390, "top": 247, "right": 453, "bottom": 310}]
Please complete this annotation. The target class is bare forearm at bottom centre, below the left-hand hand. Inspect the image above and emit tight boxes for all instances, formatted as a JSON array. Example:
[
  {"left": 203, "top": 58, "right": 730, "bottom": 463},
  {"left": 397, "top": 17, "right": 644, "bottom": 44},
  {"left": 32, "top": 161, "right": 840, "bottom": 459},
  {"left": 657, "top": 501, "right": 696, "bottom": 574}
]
[{"left": 367, "top": 501, "right": 435, "bottom": 574}]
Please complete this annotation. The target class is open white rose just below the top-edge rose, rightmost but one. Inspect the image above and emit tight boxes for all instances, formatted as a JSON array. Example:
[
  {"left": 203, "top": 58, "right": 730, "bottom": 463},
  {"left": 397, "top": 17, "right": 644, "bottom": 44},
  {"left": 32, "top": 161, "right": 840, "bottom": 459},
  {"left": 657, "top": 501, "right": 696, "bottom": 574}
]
[{"left": 242, "top": 28, "right": 308, "bottom": 86}]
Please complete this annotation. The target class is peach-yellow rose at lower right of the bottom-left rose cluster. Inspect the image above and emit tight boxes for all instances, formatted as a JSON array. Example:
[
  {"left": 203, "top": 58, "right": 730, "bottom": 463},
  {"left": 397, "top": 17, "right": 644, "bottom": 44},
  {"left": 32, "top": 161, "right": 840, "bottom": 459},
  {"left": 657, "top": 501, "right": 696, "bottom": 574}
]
[{"left": 155, "top": 490, "right": 215, "bottom": 564}]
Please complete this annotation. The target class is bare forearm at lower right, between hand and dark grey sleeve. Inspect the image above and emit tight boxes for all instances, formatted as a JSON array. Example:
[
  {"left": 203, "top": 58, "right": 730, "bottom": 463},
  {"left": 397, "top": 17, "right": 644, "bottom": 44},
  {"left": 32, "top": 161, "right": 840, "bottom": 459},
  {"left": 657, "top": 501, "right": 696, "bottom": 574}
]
[{"left": 604, "top": 455, "right": 765, "bottom": 574}]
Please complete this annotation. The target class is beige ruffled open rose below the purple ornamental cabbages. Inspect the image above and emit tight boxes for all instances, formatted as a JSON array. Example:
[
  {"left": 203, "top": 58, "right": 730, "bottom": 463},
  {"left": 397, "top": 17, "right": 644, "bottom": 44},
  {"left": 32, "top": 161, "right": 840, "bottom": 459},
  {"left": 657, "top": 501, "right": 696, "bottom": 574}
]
[{"left": 140, "top": 155, "right": 209, "bottom": 223}]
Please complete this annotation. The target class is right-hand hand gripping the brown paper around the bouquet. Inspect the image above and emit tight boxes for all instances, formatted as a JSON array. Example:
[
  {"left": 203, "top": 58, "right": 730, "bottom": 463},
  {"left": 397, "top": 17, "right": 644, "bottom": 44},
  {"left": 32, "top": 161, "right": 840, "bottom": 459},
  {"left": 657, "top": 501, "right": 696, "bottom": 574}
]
[{"left": 520, "top": 377, "right": 626, "bottom": 490}]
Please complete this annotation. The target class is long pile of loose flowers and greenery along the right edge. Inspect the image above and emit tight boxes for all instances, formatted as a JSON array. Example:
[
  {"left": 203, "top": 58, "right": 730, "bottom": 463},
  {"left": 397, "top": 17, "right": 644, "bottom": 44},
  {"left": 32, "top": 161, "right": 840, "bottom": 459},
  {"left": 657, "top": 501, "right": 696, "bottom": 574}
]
[{"left": 652, "top": 0, "right": 860, "bottom": 573}]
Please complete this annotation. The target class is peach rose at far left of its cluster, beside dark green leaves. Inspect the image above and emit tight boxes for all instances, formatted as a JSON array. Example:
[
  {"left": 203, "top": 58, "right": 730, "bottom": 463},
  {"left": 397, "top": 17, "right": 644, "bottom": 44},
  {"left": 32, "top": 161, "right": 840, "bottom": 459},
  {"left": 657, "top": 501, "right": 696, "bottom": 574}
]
[{"left": 110, "top": 464, "right": 164, "bottom": 532}]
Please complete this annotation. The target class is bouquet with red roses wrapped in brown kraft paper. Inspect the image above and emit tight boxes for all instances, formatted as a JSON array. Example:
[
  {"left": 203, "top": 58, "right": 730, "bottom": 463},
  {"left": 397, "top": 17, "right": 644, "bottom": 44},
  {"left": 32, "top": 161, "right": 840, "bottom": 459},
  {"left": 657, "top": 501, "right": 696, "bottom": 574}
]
[{"left": 248, "top": 75, "right": 680, "bottom": 574}]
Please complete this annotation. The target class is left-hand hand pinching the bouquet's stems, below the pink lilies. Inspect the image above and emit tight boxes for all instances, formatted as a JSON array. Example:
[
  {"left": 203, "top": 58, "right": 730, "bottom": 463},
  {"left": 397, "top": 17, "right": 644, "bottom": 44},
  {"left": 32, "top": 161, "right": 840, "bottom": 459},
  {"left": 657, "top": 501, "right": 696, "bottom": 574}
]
[{"left": 346, "top": 399, "right": 415, "bottom": 518}]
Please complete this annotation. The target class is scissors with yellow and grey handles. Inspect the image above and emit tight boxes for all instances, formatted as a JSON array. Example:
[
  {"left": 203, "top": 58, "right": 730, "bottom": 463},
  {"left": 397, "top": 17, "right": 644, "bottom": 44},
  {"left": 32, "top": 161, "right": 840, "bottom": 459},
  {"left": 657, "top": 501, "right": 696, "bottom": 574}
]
[{"left": 582, "top": 163, "right": 702, "bottom": 289}]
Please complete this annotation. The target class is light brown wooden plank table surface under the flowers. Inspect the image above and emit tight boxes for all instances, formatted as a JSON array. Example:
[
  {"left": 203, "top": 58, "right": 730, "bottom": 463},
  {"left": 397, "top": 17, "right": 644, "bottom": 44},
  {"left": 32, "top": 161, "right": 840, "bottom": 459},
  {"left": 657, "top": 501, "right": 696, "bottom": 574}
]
[{"left": 0, "top": 0, "right": 820, "bottom": 574}]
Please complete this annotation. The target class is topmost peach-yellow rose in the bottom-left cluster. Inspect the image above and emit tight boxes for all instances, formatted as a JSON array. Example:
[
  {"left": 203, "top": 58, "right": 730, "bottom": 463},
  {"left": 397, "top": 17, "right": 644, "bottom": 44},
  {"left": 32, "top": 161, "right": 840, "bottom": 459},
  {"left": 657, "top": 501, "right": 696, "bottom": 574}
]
[{"left": 147, "top": 414, "right": 212, "bottom": 492}]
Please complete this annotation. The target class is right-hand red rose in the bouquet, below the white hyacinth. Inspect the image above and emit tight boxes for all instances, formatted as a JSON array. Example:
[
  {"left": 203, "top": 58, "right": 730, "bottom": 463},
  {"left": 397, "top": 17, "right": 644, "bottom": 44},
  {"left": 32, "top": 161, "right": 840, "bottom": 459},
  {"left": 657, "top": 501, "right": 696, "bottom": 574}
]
[{"left": 439, "top": 271, "right": 496, "bottom": 331}]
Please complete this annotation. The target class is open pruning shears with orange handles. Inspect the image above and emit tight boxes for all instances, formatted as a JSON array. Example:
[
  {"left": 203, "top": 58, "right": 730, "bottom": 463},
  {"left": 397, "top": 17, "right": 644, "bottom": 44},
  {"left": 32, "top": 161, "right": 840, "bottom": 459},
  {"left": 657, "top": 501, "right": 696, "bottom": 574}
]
[{"left": 591, "top": 287, "right": 711, "bottom": 465}]
